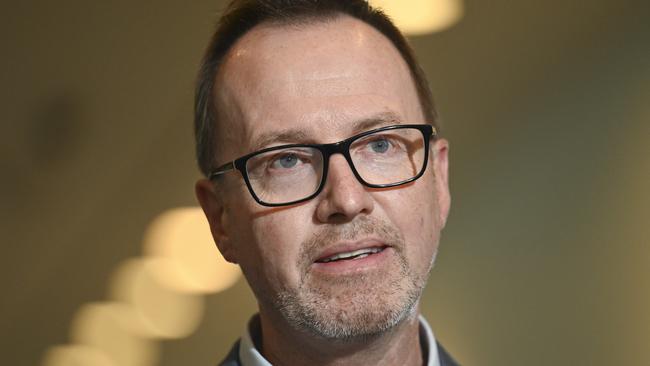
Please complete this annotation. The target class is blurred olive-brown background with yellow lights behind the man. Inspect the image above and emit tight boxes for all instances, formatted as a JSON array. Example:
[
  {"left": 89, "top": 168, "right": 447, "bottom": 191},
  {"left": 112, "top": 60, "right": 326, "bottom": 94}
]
[{"left": 0, "top": 0, "right": 650, "bottom": 366}]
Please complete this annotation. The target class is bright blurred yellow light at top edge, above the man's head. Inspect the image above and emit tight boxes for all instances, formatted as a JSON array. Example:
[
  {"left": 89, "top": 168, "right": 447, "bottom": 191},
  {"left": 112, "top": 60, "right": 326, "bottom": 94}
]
[{"left": 369, "top": 0, "right": 463, "bottom": 35}]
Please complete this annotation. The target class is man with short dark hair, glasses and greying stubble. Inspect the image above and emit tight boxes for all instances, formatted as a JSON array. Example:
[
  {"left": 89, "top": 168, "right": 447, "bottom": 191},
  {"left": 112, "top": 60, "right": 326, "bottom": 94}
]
[{"left": 195, "top": 0, "right": 455, "bottom": 366}]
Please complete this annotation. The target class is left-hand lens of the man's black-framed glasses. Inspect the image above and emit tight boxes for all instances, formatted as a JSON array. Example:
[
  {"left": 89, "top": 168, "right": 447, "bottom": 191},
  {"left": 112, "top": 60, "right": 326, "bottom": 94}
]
[{"left": 246, "top": 147, "right": 323, "bottom": 204}]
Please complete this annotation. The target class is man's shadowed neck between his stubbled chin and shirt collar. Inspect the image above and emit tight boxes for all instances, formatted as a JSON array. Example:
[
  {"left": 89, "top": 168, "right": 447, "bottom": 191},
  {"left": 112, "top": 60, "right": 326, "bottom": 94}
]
[{"left": 260, "top": 311, "right": 423, "bottom": 366}]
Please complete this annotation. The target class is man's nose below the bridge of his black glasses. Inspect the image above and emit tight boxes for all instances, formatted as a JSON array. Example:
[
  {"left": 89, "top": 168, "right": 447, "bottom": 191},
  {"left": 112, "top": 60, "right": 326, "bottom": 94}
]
[{"left": 316, "top": 154, "right": 374, "bottom": 222}]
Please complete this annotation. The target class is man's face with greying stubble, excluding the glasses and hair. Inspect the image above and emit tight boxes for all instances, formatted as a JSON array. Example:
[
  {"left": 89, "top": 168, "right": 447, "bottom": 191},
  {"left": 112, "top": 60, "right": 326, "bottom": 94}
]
[{"left": 197, "top": 16, "right": 449, "bottom": 338}]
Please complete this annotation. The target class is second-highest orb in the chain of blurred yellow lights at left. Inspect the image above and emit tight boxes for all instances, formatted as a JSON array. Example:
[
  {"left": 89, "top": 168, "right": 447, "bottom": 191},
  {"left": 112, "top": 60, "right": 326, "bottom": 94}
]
[{"left": 111, "top": 258, "right": 204, "bottom": 339}]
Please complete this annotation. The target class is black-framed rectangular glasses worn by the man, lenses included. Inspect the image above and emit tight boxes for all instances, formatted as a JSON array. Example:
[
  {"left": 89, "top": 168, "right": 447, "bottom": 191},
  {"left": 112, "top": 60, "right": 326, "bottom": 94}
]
[{"left": 208, "top": 124, "right": 436, "bottom": 207}]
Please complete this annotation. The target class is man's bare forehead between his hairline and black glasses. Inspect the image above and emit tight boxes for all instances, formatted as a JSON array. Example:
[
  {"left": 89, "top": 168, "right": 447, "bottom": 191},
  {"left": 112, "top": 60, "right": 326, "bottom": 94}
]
[{"left": 215, "top": 15, "right": 422, "bottom": 161}]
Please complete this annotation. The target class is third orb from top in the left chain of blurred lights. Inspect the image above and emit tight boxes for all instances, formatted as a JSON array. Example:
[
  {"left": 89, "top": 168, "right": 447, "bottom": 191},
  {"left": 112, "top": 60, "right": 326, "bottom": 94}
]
[{"left": 68, "top": 302, "right": 159, "bottom": 366}]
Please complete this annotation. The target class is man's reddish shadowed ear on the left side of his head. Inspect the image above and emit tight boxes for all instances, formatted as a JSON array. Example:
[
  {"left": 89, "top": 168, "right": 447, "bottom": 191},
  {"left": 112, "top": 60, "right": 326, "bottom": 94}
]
[{"left": 194, "top": 179, "right": 237, "bottom": 263}]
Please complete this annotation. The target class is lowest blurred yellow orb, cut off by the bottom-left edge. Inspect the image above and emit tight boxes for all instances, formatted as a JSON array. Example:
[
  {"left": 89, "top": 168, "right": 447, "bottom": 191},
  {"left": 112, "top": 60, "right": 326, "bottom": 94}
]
[{"left": 41, "top": 344, "right": 119, "bottom": 366}]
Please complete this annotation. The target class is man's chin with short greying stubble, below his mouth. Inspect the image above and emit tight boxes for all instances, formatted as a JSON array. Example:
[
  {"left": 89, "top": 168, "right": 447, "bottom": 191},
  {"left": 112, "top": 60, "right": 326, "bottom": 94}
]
[{"left": 275, "top": 264, "right": 426, "bottom": 343}]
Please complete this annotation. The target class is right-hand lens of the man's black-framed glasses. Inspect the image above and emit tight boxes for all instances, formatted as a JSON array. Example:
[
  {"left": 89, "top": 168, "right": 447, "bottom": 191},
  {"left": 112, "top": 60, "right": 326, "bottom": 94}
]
[{"left": 350, "top": 128, "right": 426, "bottom": 185}]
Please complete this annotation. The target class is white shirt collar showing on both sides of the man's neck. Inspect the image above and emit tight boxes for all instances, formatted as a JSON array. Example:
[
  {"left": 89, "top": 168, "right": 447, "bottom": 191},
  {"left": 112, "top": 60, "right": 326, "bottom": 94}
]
[{"left": 239, "top": 315, "right": 440, "bottom": 366}]
